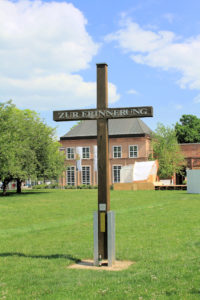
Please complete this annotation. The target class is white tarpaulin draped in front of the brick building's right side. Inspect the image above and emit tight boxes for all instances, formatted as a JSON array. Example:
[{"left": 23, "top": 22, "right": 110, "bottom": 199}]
[{"left": 120, "top": 161, "right": 158, "bottom": 183}]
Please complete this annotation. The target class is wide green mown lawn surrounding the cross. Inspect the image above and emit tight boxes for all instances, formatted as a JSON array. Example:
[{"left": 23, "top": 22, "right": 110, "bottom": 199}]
[{"left": 0, "top": 190, "right": 200, "bottom": 300}]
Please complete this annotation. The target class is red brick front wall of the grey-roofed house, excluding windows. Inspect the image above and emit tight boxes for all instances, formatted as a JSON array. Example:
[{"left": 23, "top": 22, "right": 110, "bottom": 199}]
[{"left": 60, "top": 135, "right": 151, "bottom": 186}]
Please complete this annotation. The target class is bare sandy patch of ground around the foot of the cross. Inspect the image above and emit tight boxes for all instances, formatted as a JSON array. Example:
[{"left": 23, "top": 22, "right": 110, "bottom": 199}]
[{"left": 68, "top": 259, "right": 135, "bottom": 271}]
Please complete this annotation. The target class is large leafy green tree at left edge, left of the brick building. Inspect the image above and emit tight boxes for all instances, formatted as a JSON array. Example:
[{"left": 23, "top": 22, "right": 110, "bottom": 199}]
[{"left": 0, "top": 102, "right": 64, "bottom": 194}]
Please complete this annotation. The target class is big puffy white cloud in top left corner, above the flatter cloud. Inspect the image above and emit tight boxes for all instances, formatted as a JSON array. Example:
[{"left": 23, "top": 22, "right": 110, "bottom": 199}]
[{"left": 0, "top": 0, "right": 98, "bottom": 77}]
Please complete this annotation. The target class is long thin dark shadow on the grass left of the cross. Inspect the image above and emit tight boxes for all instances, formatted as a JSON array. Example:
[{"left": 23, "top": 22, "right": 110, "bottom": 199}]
[{"left": 0, "top": 252, "right": 81, "bottom": 263}]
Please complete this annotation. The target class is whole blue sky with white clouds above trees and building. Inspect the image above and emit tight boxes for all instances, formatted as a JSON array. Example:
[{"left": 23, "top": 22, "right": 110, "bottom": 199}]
[{"left": 0, "top": 0, "right": 200, "bottom": 136}]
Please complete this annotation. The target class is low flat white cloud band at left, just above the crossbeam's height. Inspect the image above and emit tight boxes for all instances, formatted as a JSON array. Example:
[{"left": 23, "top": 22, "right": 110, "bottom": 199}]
[{"left": 0, "top": 74, "right": 119, "bottom": 110}]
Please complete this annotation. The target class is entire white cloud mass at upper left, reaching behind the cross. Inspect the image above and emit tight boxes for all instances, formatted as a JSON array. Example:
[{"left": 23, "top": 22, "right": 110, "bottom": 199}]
[{"left": 0, "top": 0, "right": 119, "bottom": 110}]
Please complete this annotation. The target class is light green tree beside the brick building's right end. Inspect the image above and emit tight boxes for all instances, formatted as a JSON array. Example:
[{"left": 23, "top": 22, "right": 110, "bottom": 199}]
[{"left": 152, "top": 123, "right": 185, "bottom": 178}]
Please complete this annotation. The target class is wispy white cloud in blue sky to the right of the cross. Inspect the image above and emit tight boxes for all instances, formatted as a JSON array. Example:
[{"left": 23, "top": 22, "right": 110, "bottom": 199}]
[{"left": 106, "top": 20, "right": 200, "bottom": 90}]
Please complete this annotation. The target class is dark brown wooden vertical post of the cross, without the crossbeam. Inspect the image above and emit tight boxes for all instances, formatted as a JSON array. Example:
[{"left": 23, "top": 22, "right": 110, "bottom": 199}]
[{"left": 97, "top": 63, "right": 110, "bottom": 259}]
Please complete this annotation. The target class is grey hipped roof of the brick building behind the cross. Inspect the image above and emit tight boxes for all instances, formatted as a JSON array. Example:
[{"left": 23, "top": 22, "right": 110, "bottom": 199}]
[{"left": 60, "top": 118, "right": 152, "bottom": 140}]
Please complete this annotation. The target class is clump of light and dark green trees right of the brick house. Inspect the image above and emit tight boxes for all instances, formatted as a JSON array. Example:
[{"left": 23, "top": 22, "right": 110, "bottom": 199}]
[{"left": 150, "top": 115, "right": 200, "bottom": 178}]
